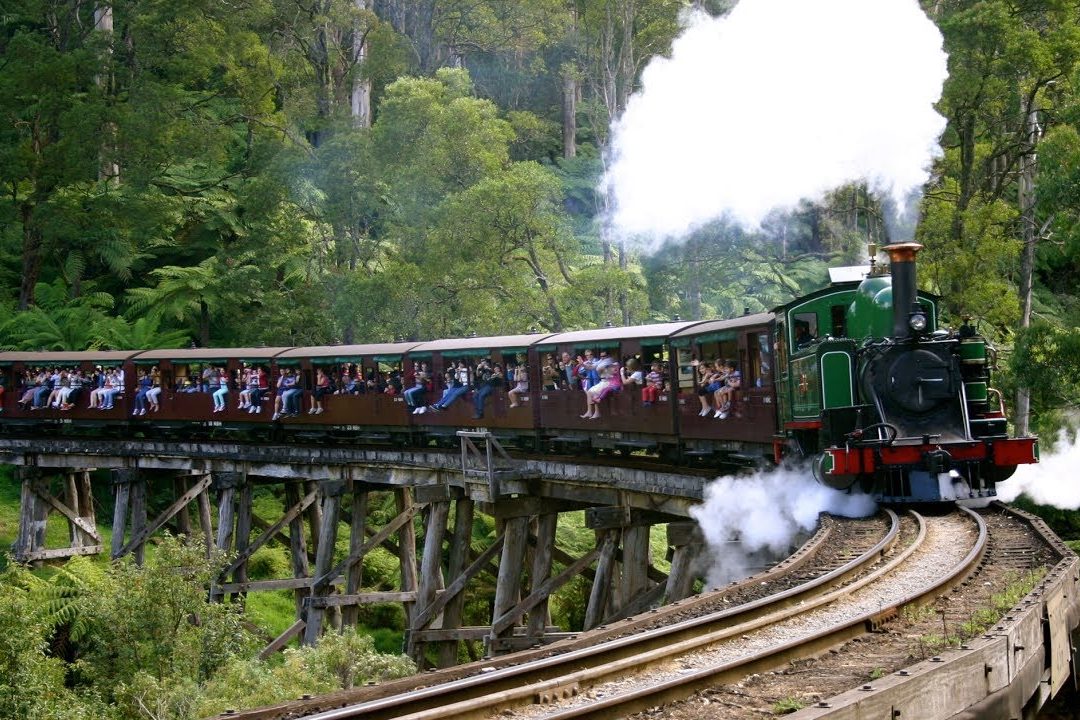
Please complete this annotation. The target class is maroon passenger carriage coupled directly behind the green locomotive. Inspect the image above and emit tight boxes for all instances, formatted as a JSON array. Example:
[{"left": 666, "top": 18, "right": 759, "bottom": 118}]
[{"left": 671, "top": 313, "right": 777, "bottom": 460}]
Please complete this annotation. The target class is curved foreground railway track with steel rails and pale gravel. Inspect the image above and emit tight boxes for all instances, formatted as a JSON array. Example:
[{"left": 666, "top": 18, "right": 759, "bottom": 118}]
[{"left": 225, "top": 512, "right": 986, "bottom": 720}]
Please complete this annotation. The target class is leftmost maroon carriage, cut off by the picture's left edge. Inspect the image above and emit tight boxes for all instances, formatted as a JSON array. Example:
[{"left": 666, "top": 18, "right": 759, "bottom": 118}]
[{"left": 0, "top": 350, "right": 138, "bottom": 424}]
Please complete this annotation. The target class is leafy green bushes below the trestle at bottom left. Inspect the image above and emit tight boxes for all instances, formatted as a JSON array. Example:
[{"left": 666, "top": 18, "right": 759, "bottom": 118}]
[{"left": 0, "top": 526, "right": 416, "bottom": 720}]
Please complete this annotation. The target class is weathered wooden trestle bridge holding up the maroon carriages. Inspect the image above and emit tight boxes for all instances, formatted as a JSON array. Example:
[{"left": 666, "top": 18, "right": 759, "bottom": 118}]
[{"left": 0, "top": 431, "right": 704, "bottom": 666}]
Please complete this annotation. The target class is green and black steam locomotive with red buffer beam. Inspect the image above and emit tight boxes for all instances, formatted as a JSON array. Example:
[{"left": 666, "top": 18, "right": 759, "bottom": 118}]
[{"left": 778, "top": 243, "right": 1039, "bottom": 501}]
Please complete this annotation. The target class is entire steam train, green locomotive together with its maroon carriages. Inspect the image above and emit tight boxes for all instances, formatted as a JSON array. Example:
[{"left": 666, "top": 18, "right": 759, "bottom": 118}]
[{"left": 0, "top": 243, "right": 1039, "bottom": 503}]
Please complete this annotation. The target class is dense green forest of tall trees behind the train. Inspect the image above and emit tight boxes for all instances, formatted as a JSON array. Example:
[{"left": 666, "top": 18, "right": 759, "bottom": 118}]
[{"left": 6, "top": 0, "right": 1080, "bottom": 424}]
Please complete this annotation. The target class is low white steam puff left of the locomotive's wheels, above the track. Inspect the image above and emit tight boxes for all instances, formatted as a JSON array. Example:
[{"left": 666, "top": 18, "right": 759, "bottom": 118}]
[{"left": 690, "top": 467, "right": 877, "bottom": 587}]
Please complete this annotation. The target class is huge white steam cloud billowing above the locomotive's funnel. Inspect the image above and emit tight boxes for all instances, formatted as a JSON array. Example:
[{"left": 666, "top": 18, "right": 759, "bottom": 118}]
[{"left": 605, "top": 0, "right": 947, "bottom": 236}]
